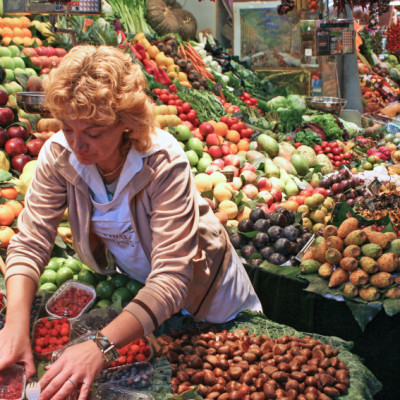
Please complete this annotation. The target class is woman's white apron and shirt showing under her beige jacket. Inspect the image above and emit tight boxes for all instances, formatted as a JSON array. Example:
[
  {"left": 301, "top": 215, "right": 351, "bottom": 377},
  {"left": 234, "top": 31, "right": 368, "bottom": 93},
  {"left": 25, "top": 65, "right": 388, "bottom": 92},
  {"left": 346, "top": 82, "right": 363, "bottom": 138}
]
[{"left": 50, "top": 130, "right": 262, "bottom": 323}]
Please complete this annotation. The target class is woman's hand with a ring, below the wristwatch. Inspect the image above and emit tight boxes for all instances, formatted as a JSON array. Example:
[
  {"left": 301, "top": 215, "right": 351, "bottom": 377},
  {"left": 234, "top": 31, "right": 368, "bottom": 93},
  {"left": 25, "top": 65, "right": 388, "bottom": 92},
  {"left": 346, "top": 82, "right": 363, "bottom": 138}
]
[{"left": 40, "top": 340, "right": 104, "bottom": 400}]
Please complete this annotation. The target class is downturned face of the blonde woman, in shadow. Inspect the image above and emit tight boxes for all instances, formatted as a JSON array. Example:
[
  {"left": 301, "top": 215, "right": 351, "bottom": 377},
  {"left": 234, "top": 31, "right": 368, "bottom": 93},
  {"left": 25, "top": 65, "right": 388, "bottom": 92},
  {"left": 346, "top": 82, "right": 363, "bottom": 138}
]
[{"left": 61, "top": 119, "right": 126, "bottom": 167}]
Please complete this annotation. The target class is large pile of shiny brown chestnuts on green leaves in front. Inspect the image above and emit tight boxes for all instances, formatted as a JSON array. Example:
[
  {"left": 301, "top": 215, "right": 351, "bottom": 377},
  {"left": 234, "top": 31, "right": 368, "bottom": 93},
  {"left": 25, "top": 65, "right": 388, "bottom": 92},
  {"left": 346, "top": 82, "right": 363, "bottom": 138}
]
[{"left": 157, "top": 329, "right": 350, "bottom": 400}]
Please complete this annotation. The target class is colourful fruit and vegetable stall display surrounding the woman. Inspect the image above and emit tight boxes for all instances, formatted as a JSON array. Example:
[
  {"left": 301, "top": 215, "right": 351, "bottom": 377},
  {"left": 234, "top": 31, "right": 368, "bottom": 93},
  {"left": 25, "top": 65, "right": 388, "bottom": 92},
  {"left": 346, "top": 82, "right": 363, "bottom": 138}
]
[{"left": 0, "top": 0, "right": 400, "bottom": 400}]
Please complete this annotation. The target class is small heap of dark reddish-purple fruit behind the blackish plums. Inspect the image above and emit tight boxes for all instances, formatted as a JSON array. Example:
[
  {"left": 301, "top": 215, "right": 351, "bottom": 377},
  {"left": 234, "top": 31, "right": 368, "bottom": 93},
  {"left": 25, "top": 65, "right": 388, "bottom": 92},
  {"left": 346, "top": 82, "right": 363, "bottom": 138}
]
[{"left": 319, "top": 168, "right": 365, "bottom": 207}]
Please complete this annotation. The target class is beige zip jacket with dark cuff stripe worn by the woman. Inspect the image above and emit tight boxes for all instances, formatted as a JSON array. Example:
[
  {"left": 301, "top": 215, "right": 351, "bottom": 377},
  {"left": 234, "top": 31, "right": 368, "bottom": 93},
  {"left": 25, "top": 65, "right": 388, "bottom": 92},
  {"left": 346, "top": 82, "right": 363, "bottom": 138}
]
[{"left": 6, "top": 132, "right": 231, "bottom": 334}]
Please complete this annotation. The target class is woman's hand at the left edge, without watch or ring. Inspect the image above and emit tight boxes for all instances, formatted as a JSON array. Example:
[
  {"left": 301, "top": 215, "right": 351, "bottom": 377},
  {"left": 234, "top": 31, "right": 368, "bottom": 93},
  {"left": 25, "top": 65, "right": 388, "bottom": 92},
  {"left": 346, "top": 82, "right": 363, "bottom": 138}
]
[{"left": 0, "top": 321, "right": 36, "bottom": 379}]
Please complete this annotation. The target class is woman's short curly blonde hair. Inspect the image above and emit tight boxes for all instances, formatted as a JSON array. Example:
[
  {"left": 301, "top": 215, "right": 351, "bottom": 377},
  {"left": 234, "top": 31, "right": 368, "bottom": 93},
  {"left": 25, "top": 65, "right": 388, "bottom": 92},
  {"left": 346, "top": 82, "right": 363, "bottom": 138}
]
[{"left": 44, "top": 45, "right": 156, "bottom": 152}]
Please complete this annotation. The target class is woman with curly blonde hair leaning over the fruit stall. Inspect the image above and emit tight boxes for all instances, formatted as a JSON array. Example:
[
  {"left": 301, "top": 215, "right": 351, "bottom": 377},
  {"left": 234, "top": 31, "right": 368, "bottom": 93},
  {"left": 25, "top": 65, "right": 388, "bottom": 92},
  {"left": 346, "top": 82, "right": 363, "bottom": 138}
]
[{"left": 0, "top": 46, "right": 261, "bottom": 400}]
